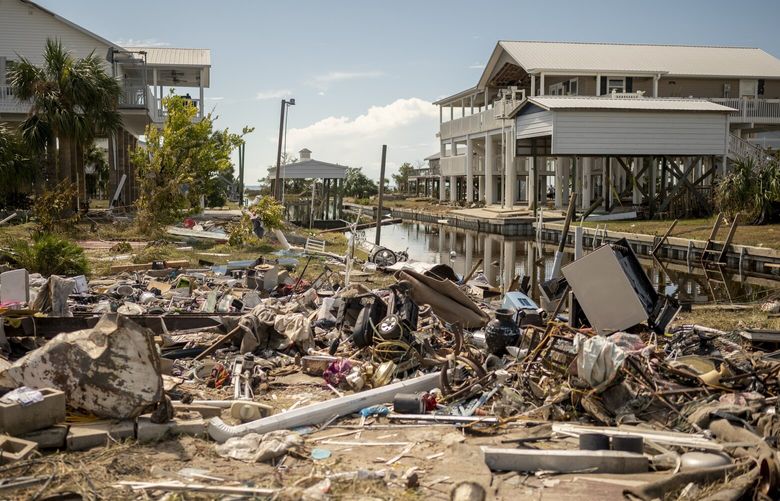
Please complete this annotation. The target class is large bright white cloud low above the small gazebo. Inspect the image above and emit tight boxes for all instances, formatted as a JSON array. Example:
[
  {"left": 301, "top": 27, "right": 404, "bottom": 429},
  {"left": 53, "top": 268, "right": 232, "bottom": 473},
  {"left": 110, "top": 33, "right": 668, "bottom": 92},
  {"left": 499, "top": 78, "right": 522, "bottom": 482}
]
[{"left": 278, "top": 97, "right": 439, "bottom": 179}]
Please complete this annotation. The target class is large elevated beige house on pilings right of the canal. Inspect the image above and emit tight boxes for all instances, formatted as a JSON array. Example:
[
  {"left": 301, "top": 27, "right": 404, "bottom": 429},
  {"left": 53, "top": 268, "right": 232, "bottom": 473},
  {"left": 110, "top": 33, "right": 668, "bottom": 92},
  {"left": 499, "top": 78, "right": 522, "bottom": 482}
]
[{"left": 435, "top": 41, "right": 780, "bottom": 216}]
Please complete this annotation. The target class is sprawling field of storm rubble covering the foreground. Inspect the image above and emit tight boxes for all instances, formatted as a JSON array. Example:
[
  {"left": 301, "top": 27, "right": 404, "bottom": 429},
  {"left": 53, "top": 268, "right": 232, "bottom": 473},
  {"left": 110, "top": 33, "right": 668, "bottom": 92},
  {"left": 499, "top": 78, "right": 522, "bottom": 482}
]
[{"left": 0, "top": 235, "right": 780, "bottom": 499}]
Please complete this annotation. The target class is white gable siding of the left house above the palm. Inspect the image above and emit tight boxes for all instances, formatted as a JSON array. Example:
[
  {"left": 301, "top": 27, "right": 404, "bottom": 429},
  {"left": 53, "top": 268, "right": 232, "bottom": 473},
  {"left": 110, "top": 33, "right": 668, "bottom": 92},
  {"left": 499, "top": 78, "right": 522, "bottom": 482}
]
[{"left": 0, "top": 0, "right": 108, "bottom": 66}]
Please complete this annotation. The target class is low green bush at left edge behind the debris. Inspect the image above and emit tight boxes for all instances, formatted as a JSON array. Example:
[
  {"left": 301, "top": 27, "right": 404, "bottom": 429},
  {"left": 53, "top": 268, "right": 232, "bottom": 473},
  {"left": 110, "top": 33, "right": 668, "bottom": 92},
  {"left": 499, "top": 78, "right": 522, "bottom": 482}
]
[{"left": 3, "top": 233, "right": 89, "bottom": 276}]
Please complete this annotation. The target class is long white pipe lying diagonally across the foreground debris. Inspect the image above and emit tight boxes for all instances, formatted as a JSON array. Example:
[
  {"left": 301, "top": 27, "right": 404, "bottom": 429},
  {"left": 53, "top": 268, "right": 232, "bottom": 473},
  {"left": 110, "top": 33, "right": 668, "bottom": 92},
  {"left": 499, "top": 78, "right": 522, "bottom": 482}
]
[{"left": 208, "top": 372, "right": 439, "bottom": 443}]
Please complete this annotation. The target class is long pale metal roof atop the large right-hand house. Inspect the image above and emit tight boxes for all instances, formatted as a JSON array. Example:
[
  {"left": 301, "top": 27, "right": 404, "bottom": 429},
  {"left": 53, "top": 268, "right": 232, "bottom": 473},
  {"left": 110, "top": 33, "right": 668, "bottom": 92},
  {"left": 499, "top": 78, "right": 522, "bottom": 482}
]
[{"left": 499, "top": 41, "right": 780, "bottom": 78}]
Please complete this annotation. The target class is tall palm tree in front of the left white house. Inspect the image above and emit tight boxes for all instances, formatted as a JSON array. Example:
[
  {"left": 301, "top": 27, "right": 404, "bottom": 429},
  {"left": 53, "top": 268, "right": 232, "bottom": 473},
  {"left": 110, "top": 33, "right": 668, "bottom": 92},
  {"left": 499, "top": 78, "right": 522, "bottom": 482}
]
[{"left": 9, "top": 39, "right": 122, "bottom": 205}]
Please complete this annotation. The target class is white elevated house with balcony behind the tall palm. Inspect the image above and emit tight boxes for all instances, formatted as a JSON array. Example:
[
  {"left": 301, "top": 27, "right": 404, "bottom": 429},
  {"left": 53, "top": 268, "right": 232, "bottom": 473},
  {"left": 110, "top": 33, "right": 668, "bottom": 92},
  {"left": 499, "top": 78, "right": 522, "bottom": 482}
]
[{"left": 0, "top": 0, "right": 211, "bottom": 205}]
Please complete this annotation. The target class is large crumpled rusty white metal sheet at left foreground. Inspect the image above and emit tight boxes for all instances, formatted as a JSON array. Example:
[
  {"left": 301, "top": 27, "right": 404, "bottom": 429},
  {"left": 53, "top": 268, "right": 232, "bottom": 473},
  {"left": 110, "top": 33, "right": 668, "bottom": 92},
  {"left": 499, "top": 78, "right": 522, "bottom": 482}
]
[{"left": 0, "top": 314, "right": 163, "bottom": 419}]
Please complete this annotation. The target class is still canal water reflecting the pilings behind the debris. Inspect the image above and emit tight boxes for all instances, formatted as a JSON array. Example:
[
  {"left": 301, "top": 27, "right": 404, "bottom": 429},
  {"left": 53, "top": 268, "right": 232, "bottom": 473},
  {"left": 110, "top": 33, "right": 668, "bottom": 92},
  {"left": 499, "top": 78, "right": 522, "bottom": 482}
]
[{"left": 356, "top": 222, "right": 780, "bottom": 304}]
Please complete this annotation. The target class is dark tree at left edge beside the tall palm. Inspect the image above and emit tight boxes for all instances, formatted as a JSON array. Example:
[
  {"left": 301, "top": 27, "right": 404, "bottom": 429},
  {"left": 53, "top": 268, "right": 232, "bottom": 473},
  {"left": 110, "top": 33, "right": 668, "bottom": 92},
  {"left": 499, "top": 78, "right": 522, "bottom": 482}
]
[{"left": 0, "top": 125, "right": 38, "bottom": 208}]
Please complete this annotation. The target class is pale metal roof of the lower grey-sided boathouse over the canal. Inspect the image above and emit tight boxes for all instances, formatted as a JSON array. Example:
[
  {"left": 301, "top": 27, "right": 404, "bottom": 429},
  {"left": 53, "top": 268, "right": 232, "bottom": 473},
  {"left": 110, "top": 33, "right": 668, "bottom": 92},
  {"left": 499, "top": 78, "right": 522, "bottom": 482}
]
[{"left": 526, "top": 96, "right": 736, "bottom": 113}]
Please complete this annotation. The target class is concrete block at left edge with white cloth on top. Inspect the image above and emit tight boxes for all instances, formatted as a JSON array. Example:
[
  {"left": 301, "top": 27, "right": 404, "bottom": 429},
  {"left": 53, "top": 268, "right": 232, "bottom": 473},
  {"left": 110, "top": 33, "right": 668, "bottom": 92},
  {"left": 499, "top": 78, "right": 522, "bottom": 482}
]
[{"left": 0, "top": 388, "right": 65, "bottom": 436}]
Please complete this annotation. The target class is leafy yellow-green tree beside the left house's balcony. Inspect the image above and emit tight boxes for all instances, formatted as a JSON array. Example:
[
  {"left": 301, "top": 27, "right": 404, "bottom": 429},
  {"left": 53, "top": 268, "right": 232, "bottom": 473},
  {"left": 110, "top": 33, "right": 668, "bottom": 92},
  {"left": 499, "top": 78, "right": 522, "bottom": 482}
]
[{"left": 130, "top": 91, "right": 252, "bottom": 228}]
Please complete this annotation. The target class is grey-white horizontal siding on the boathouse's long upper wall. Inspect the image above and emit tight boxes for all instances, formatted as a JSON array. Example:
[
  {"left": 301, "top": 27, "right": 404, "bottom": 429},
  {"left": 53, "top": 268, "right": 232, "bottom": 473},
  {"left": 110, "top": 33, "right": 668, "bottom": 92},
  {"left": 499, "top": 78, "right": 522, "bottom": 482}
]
[{"left": 552, "top": 111, "right": 727, "bottom": 155}]
